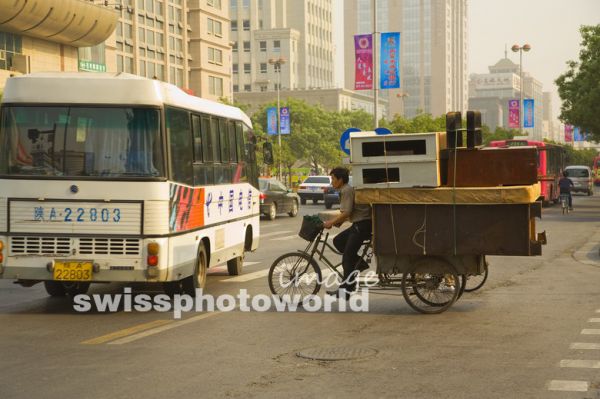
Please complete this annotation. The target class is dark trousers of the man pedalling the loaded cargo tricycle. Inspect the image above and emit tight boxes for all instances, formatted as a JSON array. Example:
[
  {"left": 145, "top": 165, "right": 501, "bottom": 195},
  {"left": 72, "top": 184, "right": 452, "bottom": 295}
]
[{"left": 333, "top": 220, "right": 372, "bottom": 292}]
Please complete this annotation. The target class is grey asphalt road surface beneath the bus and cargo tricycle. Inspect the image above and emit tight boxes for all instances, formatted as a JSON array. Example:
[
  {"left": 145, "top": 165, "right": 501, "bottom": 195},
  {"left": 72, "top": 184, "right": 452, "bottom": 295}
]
[{"left": 0, "top": 196, "right": 600, "bottom": 399}]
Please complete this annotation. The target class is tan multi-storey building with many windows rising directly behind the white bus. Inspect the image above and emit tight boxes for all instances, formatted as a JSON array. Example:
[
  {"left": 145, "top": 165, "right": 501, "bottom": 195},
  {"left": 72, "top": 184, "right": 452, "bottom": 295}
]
[{"left": 116, "top": 0, "right": 231, "bottom": 100}]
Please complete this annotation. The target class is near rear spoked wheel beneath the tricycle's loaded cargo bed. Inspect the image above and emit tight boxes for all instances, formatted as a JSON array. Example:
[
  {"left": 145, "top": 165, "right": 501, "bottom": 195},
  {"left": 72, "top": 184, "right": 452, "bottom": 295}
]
[{"left": 401, "top": 258, "right": 462, "bottom": 314}]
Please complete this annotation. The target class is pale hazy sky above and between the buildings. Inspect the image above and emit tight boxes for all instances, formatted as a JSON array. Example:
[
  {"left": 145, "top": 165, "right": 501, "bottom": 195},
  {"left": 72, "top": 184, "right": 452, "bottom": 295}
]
[{"left": 333, "top": 0, "right": 600, "bottom": 119}]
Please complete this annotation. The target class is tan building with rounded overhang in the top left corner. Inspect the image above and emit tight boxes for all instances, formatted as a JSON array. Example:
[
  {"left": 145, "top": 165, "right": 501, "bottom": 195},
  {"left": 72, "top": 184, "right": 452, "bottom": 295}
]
[{"left": 0, "top": 0, "right": 119, "bottom": 90}]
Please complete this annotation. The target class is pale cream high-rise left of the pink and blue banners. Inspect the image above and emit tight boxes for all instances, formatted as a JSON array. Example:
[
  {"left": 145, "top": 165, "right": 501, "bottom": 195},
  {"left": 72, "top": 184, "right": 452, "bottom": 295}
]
[{"left": 230, "top": 0, "right": 334, "bottom": 92}]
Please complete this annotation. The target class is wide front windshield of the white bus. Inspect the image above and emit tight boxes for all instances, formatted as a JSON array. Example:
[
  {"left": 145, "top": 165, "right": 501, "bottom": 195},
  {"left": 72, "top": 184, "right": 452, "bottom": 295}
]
[{"left": 0, "top": 106, "right": 165, "bottom": 178}]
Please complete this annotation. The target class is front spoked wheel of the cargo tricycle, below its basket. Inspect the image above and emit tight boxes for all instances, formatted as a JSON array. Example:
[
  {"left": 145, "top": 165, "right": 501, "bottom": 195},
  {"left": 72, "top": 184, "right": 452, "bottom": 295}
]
[{"left": 269, "top": 252, "right": 321, "bottom": 303}]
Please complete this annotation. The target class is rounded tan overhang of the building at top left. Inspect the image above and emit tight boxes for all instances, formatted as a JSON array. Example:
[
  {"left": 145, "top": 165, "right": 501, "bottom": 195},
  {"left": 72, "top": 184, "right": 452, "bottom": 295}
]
[{"left": 0, "top": 0, "right": 119, "bottom": 47}]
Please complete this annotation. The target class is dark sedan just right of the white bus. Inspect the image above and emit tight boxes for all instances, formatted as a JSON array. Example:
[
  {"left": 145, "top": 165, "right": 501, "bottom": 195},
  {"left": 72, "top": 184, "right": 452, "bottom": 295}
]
[{"left": 258, "top": 178, "right": 300, "bottom": 220}]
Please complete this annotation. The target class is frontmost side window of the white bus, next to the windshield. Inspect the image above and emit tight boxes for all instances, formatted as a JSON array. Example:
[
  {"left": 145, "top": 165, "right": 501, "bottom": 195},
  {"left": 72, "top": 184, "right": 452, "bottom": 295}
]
[{"left": 167, "top": 108, "right": 194, "bottom": 185}]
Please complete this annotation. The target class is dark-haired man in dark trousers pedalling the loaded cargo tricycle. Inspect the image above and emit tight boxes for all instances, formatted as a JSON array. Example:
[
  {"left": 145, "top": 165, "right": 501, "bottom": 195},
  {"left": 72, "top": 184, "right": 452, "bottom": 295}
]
[{"left": 323, "top": 167, "right": 372, "bottom": 297}]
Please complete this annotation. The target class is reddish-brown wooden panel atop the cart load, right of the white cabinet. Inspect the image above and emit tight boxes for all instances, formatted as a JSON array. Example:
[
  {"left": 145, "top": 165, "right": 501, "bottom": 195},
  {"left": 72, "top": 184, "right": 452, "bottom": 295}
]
[{"left": 441, "top": 148, "right": 537, "bottom": 187}]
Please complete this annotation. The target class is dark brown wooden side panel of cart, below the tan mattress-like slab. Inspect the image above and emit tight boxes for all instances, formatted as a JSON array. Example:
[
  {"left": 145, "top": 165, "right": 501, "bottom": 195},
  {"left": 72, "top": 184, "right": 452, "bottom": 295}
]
[{"left": 373, "top": 204, "right": 541, "bottom": 256}]
